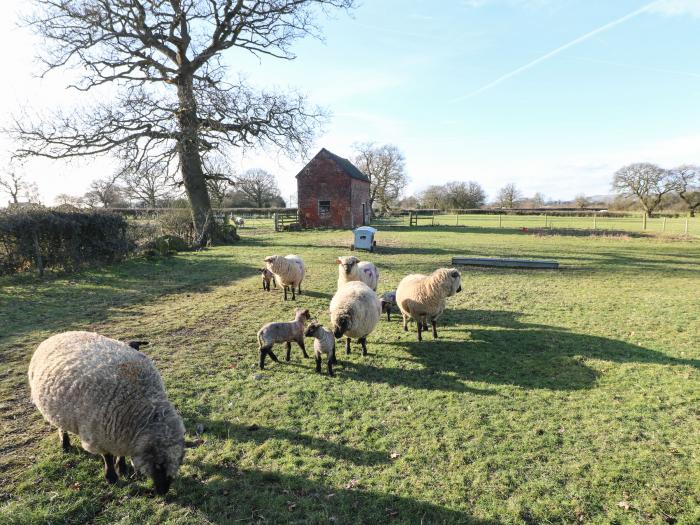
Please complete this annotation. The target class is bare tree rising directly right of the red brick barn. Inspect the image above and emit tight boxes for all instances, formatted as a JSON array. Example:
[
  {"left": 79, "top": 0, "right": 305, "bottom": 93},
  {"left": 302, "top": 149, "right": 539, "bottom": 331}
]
[{"left": 354, "top": 142, "right": 408, "bottom": 215}]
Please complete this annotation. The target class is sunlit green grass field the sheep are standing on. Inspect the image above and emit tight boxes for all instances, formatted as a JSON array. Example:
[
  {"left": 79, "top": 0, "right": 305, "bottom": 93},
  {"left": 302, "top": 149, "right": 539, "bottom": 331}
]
[{"left": 0, "top": 226, "right": 700, "bottom": 524}]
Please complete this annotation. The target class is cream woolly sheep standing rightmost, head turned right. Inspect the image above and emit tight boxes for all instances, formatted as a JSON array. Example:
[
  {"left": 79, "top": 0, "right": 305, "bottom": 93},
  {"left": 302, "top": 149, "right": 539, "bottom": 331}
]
[{"left": 396, "top": 268, "right": 462, "bottom": 341}]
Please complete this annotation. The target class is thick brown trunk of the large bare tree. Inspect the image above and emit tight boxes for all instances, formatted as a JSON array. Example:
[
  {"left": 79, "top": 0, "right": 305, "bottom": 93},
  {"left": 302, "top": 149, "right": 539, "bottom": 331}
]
[{"left": 177, "top": 76, "right": 212, "bottom": 247}]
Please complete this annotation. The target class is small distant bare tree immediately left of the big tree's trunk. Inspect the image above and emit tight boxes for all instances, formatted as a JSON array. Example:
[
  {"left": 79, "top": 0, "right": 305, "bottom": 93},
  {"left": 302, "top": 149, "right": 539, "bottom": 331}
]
[{"left": 117, "top": 159, "right": 176, "bottom": 208}]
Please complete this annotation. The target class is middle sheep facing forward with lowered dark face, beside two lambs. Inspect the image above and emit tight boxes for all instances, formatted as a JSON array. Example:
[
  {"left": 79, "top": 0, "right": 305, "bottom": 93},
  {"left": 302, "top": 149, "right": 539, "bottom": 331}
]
[{"left": 330, "top": 281, "right": 381, "bottom": 355}]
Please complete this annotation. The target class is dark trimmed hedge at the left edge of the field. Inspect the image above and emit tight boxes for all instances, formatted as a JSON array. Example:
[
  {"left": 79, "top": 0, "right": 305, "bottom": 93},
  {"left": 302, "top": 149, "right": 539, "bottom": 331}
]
[{"left": 0, "top": 206, "right": 131, "bottom": 274}]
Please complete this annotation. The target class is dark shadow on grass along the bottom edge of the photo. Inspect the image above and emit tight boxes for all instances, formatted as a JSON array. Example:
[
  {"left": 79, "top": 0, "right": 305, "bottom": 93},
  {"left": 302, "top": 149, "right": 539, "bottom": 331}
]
[{"left": 172, "top": 463, "right": 496, "bottom": 525}]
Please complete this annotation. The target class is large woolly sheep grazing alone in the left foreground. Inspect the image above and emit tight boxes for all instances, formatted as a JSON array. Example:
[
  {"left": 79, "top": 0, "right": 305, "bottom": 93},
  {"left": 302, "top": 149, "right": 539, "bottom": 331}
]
[{"left": 28, "top": 332, "right": 185, "bottom": 494}]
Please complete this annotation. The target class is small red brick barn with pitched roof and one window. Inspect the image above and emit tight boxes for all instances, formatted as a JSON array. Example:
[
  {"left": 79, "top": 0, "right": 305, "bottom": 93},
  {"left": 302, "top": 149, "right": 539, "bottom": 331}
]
[{"left": 297, "top": 148, "right": 370, "bottom": 228}]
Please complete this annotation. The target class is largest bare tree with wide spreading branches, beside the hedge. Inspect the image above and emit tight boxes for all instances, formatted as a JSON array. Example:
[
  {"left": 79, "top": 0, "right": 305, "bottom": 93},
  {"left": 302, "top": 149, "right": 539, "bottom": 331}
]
[{"left": 10, "top": 0, "right": 354, "bottom": 244}]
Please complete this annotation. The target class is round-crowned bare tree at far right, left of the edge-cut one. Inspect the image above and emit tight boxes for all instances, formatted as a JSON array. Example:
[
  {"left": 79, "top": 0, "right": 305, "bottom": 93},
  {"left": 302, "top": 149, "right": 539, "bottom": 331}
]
[{"left": 612, "top": 162, "right": 675, "bottom": 217}]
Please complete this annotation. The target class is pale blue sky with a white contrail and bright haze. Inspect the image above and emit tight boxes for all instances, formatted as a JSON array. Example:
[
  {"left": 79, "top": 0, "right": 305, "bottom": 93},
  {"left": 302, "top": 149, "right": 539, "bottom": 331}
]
[{"left": 0, "top": 0, "right": 700, "bottom": 204}]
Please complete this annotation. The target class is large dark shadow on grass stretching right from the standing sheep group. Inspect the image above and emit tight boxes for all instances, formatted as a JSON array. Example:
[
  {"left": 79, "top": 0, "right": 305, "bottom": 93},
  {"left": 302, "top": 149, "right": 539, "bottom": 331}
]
[{"left": 339, "top": 310, "right": 700, "bottom": 395}]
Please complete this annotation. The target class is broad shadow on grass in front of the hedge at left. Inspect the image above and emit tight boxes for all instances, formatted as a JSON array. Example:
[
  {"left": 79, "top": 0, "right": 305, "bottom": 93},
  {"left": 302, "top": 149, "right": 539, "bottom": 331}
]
[{"left": 0, "top": 251, "right": 257, "bottom": 344}]
